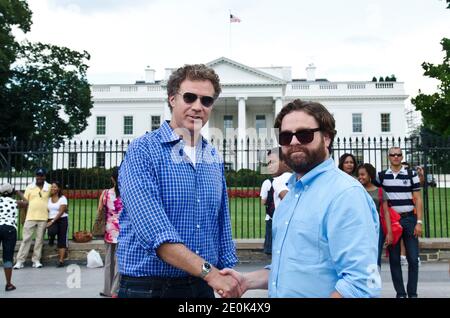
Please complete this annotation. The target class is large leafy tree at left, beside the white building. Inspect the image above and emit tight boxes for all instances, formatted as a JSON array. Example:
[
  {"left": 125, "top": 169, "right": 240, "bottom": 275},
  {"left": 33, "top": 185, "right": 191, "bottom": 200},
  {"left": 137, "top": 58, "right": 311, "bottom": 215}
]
[{"left": 0, "top": 0, "right": 93, "bottom": 147}]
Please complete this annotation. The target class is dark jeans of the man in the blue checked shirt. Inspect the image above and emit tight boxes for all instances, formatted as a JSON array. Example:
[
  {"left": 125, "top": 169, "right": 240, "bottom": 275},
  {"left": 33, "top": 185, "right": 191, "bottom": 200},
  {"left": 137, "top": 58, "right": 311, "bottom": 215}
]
[{"left": 119, "top": 276, "right": 215, "bottom": 298}]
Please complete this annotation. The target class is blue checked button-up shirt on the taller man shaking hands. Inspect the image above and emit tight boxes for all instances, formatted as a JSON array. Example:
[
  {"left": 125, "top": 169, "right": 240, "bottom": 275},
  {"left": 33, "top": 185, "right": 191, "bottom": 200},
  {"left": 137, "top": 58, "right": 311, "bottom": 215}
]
[{"left": 117, "top": 122, "right": 237, "bottom": 277}]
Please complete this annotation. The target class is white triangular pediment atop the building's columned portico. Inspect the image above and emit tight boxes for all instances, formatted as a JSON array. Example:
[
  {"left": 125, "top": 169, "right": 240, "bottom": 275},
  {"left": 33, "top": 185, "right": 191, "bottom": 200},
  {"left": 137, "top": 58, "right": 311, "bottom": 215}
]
[{"left": 206, "top": 57, "right": 286, "bottom": 86}]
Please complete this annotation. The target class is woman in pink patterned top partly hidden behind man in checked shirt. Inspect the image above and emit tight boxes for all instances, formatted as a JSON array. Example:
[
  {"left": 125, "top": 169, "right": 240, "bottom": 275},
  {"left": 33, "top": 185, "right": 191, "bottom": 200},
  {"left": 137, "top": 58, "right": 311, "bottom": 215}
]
[{"left": 94, "top": 168, "right": 123, "bottom": 298}]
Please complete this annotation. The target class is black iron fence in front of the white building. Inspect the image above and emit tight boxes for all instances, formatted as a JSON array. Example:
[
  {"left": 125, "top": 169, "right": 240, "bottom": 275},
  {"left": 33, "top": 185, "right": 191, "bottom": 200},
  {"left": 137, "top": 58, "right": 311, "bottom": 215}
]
[{"left": 0, "top": 137, "right": 450, "bottom": 238}]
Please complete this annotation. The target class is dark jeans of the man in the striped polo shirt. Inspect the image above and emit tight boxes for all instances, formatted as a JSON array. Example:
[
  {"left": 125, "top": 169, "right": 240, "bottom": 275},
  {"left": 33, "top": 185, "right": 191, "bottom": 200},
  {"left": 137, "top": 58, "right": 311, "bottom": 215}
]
[{"left": 389, "top": 215, "right": 419, "bottom": 297}]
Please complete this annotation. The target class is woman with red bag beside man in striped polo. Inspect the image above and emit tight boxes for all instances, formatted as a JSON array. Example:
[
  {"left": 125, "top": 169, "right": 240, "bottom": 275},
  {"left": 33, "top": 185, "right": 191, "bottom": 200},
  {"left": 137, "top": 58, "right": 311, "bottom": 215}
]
[{"left": 357, "top": 163, "right": 393, "bottom": 267}]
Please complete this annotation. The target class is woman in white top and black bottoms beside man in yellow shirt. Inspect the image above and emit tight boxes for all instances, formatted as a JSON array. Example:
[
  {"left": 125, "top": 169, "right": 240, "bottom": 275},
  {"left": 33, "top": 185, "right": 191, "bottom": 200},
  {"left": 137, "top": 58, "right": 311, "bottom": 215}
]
[{"left": 47, "top": 181, "right": 69, "bottom": 267}]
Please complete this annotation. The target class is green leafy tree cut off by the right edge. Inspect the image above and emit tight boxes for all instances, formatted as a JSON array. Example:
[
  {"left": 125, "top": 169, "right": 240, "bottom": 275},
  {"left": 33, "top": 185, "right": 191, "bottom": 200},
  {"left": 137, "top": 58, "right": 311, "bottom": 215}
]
[{"left": 411, "top": 38, "right": 450, "bottom": 136}]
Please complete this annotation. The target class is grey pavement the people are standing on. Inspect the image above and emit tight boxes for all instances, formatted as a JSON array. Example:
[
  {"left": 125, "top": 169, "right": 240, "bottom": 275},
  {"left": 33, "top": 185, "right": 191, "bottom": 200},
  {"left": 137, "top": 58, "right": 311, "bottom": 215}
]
[{"left": 0, "top": 262, "right": 450, "bottom": 298}]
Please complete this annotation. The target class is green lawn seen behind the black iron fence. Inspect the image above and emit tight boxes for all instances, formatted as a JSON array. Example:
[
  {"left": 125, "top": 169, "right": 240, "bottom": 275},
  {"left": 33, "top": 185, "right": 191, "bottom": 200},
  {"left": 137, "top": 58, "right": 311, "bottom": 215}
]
[{"left": 15, "top": 188, "right": 450, "bottom": 238}]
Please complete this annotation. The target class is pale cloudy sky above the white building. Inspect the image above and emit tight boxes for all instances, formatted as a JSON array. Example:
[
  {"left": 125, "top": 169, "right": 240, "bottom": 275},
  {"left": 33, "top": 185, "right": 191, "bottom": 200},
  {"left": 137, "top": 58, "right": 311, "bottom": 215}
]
[{"left": 17, "top": 0, "right": 450, "bottom": 99}]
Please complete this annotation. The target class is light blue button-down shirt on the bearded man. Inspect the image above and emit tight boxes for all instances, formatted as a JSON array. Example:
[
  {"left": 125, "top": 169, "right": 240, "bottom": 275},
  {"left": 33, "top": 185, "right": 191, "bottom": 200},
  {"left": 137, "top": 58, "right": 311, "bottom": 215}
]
[{"left": 269, "top": 159, "right": 381, "bottom": 298}]
